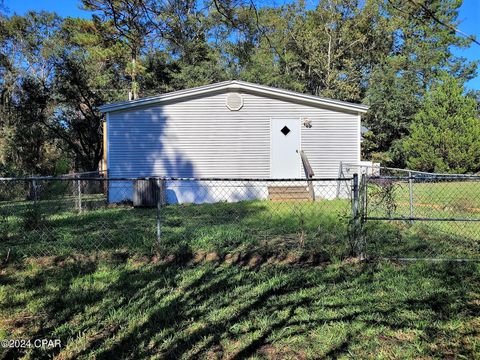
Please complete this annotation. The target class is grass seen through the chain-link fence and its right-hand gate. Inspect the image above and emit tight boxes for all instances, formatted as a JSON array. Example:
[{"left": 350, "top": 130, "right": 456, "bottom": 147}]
[{"left": 0, "top": 188, "right": 480, "bottom": 262}]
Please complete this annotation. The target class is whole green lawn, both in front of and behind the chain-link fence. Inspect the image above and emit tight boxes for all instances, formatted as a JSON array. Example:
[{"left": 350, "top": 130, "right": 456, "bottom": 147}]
[{"left": 0, "top": 191, "right": 480, "bottom": 359}]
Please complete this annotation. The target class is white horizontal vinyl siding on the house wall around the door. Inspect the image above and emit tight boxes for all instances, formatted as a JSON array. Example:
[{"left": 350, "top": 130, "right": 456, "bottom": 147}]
[{"left": 107, "top": 93, "right": 360, "bottom": 178}]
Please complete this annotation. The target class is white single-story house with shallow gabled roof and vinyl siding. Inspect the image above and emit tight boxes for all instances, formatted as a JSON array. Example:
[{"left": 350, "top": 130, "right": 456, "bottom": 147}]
[{"left": 100, "top": 81, "right": 368, "bottom": 202}]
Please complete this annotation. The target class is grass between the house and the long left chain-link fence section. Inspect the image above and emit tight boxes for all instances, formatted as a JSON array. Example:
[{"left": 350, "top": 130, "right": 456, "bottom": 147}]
[{"left": 0, "top": 198, "right": 351, "bottom": 259}]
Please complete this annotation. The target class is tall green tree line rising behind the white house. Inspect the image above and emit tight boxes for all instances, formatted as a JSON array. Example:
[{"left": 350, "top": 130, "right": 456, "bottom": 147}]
[{"left": 0, "top": 0, "right": 480, "bottom": 176}]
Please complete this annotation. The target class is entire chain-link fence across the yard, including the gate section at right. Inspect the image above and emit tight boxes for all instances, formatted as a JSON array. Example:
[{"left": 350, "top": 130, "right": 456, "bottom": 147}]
[{"left": 0, "top": 167, "right": 480, "bottom": 261}]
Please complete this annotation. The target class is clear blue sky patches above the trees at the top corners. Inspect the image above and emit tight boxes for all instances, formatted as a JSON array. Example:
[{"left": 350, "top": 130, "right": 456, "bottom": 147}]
[{"left": 4, "top": 0, "right": 480, "bottom": 90}]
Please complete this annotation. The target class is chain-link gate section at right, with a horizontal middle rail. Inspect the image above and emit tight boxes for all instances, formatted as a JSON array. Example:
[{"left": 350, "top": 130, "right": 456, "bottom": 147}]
[{"left": 348, "top": 167, "right": 480, "bottom": 261}]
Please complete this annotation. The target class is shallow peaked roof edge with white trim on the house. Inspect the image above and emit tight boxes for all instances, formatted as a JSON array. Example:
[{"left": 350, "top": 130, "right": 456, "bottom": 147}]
[{"left": 99, "top": 80, "right": 368, "bottom": 113}]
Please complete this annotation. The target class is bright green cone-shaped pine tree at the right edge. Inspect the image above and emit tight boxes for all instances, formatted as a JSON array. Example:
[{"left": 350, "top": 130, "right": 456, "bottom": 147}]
[{"left": 403, "top": 74, "right": 480, "bottom": 173}]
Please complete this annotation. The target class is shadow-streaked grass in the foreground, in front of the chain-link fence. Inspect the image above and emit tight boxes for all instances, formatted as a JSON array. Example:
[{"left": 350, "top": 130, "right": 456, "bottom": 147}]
[{"left": 0, "top": 258, "right": 480, "bottom": 359}]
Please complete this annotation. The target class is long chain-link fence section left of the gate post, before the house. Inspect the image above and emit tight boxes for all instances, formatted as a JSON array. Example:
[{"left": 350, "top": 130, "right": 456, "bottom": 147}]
[{"left": 0, "top": 177, "right": 353, "bottom": 259}]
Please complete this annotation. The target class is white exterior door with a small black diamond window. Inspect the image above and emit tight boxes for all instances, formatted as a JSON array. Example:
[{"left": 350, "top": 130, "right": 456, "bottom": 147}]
[{"left": 270, "top": 118, "right": 301, "bottom": 179}]
